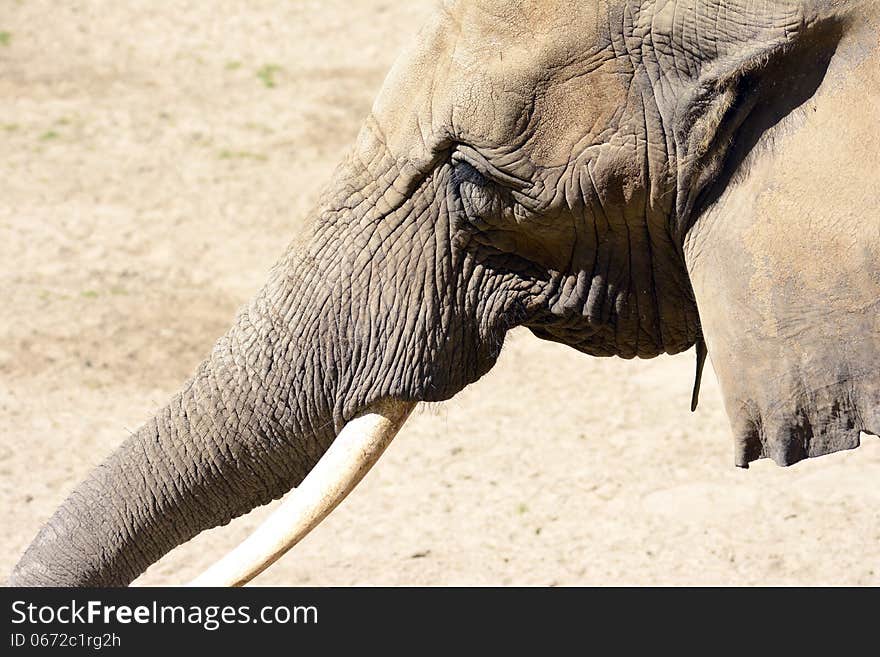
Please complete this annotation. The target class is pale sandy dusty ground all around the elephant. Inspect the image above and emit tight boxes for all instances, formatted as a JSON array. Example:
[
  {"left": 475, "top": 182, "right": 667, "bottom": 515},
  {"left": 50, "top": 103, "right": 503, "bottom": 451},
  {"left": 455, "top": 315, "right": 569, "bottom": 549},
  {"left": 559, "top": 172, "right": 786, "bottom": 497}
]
[{"left": 0, "top": 0, "right": 880, "bottom": 585}]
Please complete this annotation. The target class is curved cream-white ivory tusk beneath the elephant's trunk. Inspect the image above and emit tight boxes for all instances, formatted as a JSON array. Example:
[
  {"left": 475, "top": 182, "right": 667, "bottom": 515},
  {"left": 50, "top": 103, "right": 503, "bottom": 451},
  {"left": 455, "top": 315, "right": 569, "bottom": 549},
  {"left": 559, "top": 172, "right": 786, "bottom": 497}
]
[{"left": 189, "top": 400, "right": 415, "bottom": 586}]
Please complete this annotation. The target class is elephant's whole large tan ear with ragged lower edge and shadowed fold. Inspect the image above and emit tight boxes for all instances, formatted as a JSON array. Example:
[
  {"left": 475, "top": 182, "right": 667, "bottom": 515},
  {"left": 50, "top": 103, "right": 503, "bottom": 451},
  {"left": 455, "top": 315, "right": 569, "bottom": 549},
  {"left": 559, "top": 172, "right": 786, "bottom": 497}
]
[{"left": 676, "top": 15, "right": 880, "bottom": 467}]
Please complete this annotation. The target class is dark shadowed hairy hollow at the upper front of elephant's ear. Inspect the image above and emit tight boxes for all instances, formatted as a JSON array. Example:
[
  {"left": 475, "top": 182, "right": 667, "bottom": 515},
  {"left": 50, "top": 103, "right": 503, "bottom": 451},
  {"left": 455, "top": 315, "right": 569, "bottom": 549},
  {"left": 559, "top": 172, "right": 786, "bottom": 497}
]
[{"left": 671, "top": 21, "right": 842, "bottom": 241}]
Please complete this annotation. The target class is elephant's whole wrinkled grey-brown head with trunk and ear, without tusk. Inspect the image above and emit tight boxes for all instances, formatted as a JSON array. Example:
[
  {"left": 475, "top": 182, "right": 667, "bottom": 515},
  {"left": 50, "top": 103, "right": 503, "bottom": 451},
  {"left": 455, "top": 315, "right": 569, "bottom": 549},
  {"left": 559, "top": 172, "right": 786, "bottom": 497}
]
[{"left": 11, "top": 0, "right": 880, "bottom": 586}]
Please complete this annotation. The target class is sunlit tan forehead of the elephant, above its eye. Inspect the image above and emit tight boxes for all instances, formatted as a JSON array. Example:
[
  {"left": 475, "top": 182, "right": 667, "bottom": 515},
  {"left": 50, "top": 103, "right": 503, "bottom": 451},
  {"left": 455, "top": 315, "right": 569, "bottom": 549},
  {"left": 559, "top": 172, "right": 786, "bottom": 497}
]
[{"left": 364, "top": 1, "right": 626, "bottom": 172}]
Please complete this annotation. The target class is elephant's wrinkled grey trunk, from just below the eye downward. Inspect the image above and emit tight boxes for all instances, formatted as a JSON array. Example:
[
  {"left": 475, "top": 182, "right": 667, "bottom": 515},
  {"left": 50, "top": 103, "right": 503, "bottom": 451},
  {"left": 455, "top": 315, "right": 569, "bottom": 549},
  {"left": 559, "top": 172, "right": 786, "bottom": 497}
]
[{"left": 9, "top": 128, "right": 513, "bottom": 586}]
